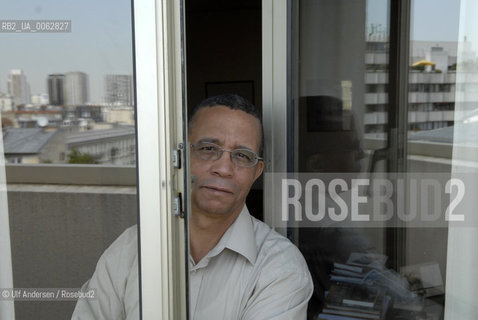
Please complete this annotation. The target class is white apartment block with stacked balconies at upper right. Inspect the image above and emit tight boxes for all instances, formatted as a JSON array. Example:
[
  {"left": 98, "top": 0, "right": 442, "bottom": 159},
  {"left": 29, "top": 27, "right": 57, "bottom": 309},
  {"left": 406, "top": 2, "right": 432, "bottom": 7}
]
[{"left": 363, "top": 39, "right": 478, "bottom": 138}]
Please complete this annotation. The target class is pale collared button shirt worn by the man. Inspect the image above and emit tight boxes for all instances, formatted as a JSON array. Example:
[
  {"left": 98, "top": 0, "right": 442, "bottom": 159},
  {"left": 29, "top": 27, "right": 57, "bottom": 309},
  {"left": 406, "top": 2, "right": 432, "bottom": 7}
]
[{"left": 72, "top": 206, "right": 313, "bottom": 320}]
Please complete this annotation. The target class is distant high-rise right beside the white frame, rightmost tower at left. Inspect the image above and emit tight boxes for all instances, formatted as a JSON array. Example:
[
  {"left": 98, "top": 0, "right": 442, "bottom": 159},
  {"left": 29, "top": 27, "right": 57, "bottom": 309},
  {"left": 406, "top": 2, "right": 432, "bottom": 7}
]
[{"left": 105, "top": 74, "right": 133, "bottom": 106}]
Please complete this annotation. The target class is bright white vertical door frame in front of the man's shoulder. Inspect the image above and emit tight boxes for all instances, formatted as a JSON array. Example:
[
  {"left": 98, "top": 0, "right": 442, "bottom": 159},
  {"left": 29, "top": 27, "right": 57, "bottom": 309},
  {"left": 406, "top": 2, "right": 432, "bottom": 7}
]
[{"left": 134, "top": 0, "right": 187, "bottom": 319}]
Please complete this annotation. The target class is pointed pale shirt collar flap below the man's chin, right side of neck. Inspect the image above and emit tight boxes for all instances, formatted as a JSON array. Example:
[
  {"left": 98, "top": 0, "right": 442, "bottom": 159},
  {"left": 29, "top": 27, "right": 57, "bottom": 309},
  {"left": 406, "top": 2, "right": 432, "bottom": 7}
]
[{"left": 207, "top": 205, "right": 257, "bottom": 264}]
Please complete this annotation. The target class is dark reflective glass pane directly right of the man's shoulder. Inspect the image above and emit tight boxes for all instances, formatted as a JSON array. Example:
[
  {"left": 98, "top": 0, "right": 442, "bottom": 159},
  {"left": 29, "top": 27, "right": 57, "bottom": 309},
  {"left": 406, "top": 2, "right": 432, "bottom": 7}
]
[{"left": 296, "top": 1, "right": 393, "bottom": 319}]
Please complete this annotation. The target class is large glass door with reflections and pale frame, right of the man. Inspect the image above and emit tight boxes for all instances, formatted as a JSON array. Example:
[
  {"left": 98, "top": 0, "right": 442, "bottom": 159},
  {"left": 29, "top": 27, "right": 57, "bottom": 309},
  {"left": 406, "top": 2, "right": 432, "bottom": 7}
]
[{"left": 263, "top": 0, "right": 477, "bottom": 319}]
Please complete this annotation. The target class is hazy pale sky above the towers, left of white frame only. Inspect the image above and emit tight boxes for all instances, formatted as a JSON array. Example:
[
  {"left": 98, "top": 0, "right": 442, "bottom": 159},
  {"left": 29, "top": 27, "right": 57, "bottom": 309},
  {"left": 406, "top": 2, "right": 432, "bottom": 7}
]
[{"left": 0, "top": 0, "right": 133, "bottom": 102}]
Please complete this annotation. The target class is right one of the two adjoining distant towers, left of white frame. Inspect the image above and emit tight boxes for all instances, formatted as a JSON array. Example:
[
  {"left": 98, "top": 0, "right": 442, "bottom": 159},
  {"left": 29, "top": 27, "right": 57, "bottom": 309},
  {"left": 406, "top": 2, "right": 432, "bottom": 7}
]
[{"left": 63, "top": 72, "right": 88, "bottom": 106}]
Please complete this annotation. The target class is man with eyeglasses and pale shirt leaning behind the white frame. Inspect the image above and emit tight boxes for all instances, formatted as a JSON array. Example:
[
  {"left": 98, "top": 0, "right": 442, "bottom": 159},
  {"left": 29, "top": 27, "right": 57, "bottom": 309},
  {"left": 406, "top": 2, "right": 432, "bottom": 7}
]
[{"left": 73, "top": 95, "right": 313, "bottom": 320}]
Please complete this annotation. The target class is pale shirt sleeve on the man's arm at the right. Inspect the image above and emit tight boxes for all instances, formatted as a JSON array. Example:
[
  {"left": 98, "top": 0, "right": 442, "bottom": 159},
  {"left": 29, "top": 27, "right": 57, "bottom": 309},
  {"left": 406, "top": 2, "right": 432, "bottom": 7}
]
[{"left": 241, "top": 244, "right": 314, "bottom": 320}]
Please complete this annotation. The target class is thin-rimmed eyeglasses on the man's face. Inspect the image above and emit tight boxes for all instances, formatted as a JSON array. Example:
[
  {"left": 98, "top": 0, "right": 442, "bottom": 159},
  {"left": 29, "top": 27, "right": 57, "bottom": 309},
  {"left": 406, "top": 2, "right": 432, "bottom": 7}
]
[{"left": 191, "top": 142, "right": 262, "bottom": 168}]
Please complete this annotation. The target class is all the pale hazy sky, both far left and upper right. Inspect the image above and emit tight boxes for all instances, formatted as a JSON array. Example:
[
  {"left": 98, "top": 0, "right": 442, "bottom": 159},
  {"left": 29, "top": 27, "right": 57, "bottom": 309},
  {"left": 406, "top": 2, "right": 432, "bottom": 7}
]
[{"left": 0, "top": 0, "right": 470, "bottom": 102}]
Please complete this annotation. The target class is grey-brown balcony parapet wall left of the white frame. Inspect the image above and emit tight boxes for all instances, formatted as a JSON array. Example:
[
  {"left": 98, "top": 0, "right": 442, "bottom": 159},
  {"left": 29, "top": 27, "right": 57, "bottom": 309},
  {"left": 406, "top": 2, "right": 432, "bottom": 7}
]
[{"left": 7, "top": 166, "right": 137, "bottom": 320}]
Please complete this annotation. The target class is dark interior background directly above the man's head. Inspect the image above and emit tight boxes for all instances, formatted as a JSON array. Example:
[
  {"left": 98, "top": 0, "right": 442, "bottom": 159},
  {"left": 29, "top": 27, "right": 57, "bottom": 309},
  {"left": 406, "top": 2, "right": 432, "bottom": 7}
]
[{"left": 186, "top": 0, "right": 262, "bottom": 110}]
